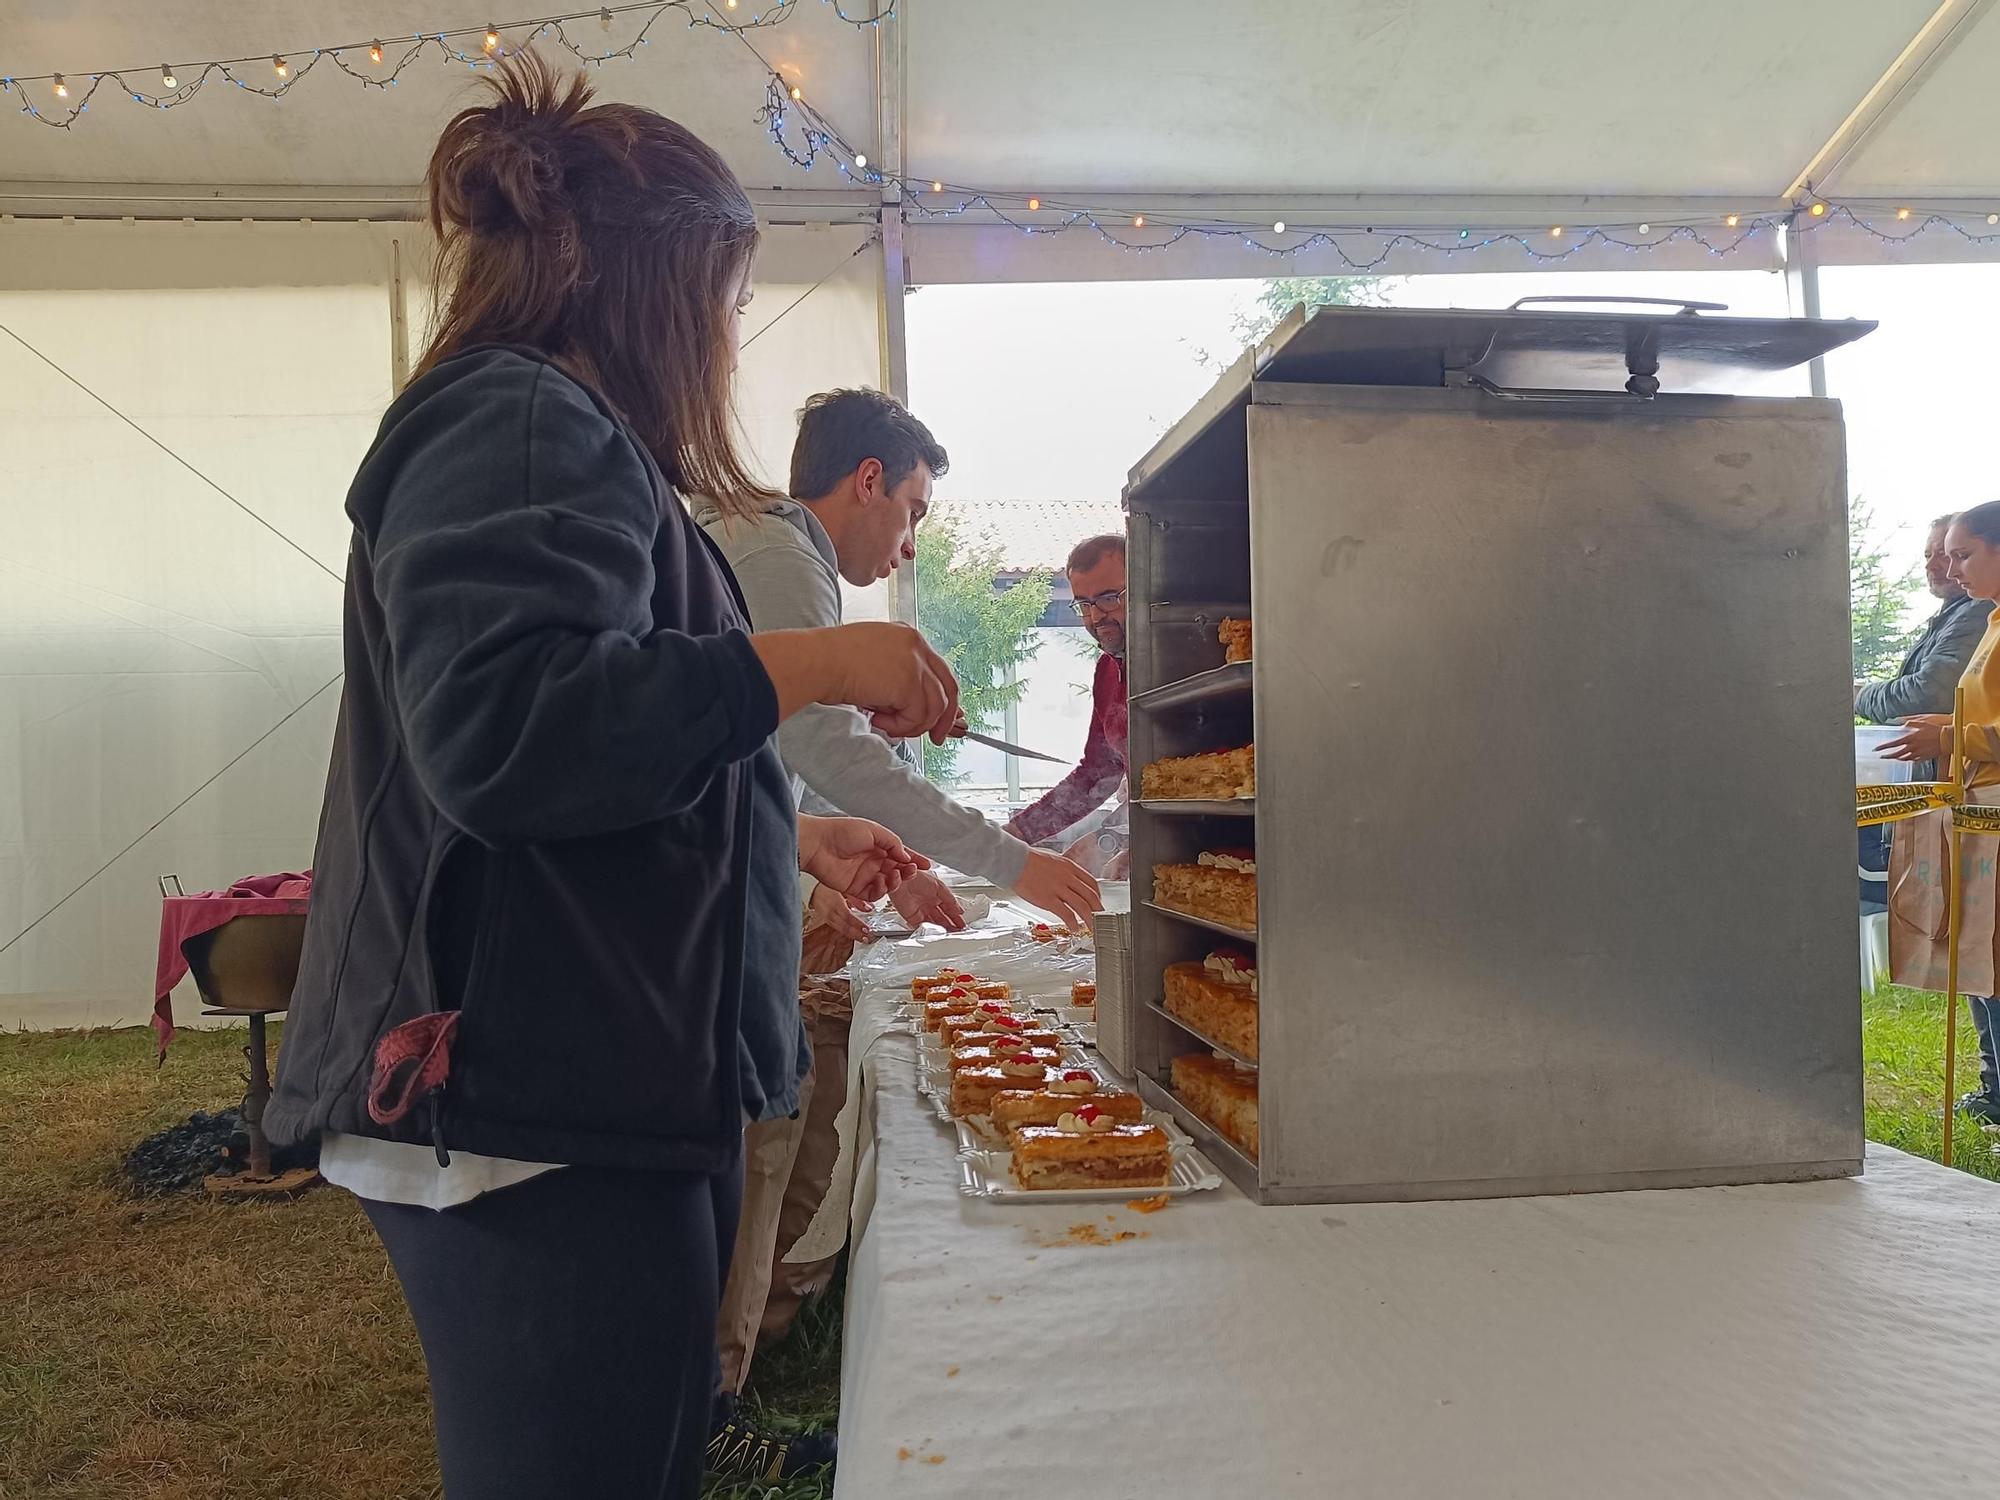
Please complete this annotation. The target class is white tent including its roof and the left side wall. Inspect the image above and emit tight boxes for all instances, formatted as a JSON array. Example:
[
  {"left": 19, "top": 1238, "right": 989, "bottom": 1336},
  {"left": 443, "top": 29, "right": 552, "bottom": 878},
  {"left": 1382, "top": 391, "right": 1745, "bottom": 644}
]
[{"left": 0, "top": 0, "right": 2000, "bottom": 1024}]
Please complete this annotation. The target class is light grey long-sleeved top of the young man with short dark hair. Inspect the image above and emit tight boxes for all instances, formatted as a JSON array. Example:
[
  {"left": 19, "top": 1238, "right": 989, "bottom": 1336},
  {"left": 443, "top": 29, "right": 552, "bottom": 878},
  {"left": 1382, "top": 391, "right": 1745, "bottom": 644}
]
[{"left": 694, "top": 500, "right": 1028, "bottom": 886}]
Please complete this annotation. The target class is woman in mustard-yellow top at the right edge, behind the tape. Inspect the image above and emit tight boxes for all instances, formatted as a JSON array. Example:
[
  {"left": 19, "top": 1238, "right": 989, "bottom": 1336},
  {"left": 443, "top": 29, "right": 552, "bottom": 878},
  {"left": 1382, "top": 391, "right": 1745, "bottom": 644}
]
[{"left": 1882, "top": 500, "right": 2000, "bottom": 1126}]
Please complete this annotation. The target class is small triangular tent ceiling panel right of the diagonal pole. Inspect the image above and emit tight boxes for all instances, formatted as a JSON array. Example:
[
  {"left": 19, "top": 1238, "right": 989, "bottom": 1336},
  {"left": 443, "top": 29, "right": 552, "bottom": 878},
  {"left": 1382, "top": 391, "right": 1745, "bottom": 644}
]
[{"left": 1828, "top": 14, "right": 2000, "bottom": 206}]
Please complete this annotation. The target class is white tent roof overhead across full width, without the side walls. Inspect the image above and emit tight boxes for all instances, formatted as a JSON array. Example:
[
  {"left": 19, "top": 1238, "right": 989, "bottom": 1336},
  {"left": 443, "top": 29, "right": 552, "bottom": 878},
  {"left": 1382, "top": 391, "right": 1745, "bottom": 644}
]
[{"left": 0, "top": 0, "right": 2000, "bottom": 280}]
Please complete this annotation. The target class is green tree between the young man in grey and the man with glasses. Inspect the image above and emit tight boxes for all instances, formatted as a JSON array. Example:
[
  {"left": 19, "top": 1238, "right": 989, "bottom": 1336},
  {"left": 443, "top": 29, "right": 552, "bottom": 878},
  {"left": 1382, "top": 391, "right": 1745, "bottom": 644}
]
[{"left": 916, "top": 508, "right": 1054, "bottom": 782}]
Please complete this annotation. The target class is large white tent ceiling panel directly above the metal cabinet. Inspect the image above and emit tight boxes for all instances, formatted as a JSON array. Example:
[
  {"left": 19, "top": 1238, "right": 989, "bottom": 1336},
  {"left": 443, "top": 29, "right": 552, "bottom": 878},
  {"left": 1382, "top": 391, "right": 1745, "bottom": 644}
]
[{"left": 908, "top": 0, "right": 1934, "bottom": 196}]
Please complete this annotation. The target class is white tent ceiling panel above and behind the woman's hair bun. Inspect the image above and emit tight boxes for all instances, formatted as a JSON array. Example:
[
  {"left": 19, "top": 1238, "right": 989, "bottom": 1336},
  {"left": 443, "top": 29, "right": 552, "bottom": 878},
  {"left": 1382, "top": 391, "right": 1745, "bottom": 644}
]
[{"left": 0, "top": 0, "right": 874, "bottom": 186}]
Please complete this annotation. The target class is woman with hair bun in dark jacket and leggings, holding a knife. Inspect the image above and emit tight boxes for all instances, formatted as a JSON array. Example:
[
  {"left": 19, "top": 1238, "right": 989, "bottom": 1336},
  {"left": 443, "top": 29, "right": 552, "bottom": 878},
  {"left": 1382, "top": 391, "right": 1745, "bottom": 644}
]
[{"left": 268, "top": 56, "right": 958, "bottom": 1500}]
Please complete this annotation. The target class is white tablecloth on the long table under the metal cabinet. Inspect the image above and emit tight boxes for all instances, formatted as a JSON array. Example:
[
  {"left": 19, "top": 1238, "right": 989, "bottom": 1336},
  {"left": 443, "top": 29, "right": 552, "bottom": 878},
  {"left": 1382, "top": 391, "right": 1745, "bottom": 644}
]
[{"left": 836, "top": 940, "right": 2000, "bottom": 1500}]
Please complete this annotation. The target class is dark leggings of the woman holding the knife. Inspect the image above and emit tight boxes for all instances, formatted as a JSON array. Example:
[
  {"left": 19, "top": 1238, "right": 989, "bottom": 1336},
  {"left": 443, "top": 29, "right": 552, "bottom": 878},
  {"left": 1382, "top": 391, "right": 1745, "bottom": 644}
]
[{"left": 364, "top": 1160, "right": 742, "bottom": 1500}]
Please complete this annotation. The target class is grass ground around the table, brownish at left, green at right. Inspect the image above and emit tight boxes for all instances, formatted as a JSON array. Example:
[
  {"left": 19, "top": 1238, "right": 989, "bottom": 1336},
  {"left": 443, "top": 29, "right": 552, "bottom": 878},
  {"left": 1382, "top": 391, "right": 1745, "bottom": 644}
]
[{"left": 0, "top": 990, "right": 2000, "bottom": 1500}]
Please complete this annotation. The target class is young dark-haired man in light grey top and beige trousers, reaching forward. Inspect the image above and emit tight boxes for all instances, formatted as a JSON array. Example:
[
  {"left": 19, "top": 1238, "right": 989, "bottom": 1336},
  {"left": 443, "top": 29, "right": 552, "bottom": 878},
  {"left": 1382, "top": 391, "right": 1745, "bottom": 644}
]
[{"left": 694, "top": 390, "right": 1098, "bottom": 1440}]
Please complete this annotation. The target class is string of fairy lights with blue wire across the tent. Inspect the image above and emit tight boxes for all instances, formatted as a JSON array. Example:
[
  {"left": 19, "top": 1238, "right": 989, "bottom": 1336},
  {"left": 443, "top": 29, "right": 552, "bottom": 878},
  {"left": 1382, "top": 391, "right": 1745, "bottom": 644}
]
[{"left": 0, "top": 0, "right": 2000, "bottom": 274}]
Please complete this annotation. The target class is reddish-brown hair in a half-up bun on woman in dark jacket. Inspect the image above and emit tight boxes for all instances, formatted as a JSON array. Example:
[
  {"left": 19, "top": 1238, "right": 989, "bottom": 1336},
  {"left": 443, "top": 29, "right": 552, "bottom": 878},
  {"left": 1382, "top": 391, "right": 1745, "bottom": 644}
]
[{"left": 418, "top": 52, "right": 776, "bottom": 514}]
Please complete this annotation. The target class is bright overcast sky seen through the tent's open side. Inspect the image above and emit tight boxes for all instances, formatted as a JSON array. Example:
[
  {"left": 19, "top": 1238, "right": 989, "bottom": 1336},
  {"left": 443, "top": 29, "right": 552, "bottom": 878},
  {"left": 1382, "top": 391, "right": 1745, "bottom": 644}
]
[{"left": 908, "top": 266, "right": 2000, "bottom": 624}]
